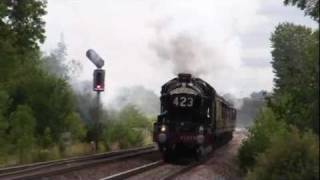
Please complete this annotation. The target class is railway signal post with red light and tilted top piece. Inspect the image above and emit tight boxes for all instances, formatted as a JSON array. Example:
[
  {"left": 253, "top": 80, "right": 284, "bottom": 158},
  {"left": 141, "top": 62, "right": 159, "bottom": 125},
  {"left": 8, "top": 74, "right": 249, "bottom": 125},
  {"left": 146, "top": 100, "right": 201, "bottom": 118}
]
[{"left": 86, "top": 49, "right": 105, "bottom": 151}]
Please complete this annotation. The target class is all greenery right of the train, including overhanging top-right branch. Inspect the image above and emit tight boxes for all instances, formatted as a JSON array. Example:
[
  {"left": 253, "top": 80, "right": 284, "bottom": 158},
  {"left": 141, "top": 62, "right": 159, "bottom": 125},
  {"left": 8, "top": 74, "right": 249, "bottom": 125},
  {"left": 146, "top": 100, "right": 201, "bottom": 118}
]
[{"left": 238, "top": 0, "right": 319, "bottom": 180}]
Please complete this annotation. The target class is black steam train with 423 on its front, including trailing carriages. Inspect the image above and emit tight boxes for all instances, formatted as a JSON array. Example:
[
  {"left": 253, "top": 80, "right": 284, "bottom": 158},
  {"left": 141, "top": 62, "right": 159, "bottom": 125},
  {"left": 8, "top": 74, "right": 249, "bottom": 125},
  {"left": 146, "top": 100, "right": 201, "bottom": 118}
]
[{"left": 153, "top": 73, "right": 236, "bottom": 160}]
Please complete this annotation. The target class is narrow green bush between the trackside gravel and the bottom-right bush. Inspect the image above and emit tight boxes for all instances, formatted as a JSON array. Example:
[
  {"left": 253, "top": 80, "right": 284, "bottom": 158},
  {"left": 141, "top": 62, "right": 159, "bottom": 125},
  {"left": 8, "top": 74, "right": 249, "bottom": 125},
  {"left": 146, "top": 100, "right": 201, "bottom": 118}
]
[{"left": 237, "top": 107, "right": 287, "bottom": 173}]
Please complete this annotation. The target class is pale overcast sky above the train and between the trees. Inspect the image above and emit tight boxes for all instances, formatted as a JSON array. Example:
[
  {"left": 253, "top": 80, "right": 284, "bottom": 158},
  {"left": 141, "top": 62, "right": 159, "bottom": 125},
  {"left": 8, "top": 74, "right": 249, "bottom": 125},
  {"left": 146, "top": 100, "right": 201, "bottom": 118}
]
[{"left": 42, "top": 0, "right": 317, "bottom": 104}]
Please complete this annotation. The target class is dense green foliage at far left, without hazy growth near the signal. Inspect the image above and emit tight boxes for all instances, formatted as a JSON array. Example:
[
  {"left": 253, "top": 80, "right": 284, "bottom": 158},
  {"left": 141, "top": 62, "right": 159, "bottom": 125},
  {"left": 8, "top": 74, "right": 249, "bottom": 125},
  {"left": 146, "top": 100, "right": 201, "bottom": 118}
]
[{"left": 0, "top": 0, "right": 85, "bottom": 162}]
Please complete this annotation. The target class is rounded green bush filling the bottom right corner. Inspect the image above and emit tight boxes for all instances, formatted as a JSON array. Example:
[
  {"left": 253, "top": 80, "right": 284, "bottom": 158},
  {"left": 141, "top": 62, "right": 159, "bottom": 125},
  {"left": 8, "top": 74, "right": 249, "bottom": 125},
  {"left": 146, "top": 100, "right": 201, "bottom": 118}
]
[{"left": 246, "top": 128, "right": 319, "bottom": 180}]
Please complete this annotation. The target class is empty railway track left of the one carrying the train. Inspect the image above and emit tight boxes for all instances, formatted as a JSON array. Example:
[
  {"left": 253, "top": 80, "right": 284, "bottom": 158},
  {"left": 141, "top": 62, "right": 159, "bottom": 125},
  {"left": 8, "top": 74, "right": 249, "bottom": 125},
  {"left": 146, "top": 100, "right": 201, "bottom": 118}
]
[{"left": 0, "top": 146, "right": 157, "bottom": 179}]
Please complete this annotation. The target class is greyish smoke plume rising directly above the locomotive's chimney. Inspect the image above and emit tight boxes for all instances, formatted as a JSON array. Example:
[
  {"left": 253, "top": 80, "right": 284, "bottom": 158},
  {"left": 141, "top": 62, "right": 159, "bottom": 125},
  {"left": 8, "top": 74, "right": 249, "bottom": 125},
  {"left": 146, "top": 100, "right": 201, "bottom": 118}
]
[{"left": 149, "top": 20, "right": 240, "bottom": 79}]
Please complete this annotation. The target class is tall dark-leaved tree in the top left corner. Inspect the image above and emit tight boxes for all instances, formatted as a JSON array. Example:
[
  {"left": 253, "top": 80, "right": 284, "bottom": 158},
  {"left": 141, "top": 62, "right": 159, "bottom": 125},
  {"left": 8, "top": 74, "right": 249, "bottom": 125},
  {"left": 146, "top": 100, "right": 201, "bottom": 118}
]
[{"left": 0, "top": 0, "right": 46, "bottom": 84}]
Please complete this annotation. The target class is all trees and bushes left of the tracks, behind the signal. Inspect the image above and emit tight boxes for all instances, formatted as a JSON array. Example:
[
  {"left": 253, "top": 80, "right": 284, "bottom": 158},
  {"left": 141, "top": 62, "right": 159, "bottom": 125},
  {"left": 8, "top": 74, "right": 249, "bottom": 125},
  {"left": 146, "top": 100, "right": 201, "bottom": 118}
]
[{"left": 0, "top": 0, "right": 152, "bottom": 166}]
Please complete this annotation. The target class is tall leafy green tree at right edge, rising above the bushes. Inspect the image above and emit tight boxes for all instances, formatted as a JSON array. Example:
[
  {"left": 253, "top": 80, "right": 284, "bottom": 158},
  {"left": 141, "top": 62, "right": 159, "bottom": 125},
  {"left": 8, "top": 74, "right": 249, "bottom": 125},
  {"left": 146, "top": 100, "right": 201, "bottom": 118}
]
[{"left": 271, "top": 23, "right": 319, "bottom": 132}]
